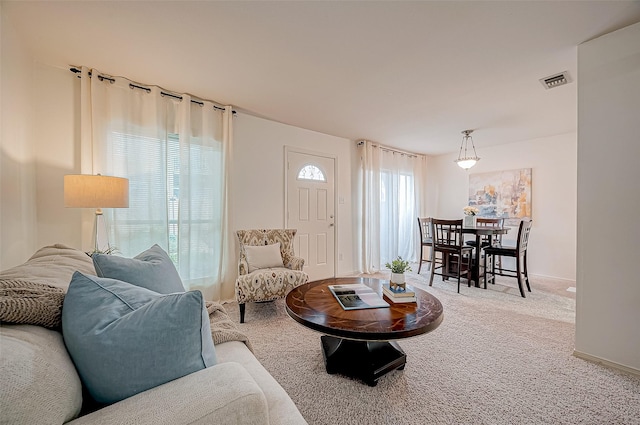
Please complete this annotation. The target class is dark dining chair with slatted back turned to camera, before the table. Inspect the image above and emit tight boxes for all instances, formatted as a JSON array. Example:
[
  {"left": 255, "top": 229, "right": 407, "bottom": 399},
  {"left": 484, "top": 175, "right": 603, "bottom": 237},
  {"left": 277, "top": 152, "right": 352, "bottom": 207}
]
[{"left": 429, "top": 218, "right": 473, "bottom": 293}]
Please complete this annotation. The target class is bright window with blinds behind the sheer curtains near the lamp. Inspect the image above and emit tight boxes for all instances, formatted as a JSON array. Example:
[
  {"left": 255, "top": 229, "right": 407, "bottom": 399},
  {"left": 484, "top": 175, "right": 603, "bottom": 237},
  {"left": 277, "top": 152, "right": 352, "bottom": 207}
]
[{"left": 110, "top": 132, "right": 222, "bottom": 279}]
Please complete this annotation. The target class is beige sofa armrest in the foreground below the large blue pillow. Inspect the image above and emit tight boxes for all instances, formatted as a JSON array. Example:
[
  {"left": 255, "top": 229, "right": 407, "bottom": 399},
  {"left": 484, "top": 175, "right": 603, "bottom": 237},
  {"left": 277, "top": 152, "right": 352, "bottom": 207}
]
[{"left": 68, "top": 362, "right": 269, "bottom": 425}]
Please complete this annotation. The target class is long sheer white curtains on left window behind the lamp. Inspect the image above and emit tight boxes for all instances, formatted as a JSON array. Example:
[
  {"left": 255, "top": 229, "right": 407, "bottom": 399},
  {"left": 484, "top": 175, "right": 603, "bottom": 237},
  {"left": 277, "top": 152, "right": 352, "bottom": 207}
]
[{"left": 81, "top": 68, "right": 233, "bottom": 300}]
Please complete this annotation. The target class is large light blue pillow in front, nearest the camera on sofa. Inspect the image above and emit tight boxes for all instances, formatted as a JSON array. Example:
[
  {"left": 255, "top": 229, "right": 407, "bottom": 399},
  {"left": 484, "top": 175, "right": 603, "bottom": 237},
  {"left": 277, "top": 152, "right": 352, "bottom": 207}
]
[{"left": 62, "top": 272, "right": 217, "bottom": 403}]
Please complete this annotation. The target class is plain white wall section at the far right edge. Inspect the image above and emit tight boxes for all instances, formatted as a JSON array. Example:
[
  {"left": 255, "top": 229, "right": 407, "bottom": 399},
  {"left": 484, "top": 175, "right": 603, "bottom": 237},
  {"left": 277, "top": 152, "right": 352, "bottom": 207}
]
[{"left": 576, "top": 24, "right": 640, "bottom": 373}]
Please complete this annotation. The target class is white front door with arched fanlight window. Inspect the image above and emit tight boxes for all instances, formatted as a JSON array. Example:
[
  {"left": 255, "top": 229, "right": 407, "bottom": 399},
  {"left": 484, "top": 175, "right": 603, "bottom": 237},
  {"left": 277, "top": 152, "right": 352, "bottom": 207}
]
[{"left": 286, "top": 151, "right": 336, "bottom": 281}]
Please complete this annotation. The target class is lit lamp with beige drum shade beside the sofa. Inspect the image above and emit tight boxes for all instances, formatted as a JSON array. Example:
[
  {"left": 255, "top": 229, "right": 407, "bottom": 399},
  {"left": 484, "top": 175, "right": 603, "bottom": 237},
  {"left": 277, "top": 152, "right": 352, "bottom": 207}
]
[{"left": 64, "top": 174, "right": 129, "bottom": 252}]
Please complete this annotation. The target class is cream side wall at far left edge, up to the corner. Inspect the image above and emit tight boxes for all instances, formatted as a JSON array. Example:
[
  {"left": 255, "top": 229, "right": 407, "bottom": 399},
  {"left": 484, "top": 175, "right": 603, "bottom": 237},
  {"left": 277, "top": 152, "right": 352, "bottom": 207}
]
[{"left": 0, "top": 3, "right": 37, "bottom": 269}]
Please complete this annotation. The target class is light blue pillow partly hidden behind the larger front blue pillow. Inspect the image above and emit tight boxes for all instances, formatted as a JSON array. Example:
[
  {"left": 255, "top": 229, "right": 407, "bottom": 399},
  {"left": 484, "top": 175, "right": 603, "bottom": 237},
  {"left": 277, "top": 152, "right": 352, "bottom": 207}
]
[{"left": 92, "top": 244, "right": 184, "bottom": 294}]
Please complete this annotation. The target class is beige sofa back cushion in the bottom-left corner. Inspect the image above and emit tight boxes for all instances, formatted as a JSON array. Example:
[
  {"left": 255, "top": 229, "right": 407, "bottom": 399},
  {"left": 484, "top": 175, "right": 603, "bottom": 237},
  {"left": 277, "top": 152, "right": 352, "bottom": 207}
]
[{"left": 0, "top": 324, "right": 82, "bottom": 424}]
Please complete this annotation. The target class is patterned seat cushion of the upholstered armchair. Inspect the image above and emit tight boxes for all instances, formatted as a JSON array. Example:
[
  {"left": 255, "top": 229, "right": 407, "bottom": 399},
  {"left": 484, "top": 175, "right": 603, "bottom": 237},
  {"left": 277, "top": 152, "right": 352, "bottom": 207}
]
[{"left": 236, "top": 268, "right": 309, "bottom": 304}]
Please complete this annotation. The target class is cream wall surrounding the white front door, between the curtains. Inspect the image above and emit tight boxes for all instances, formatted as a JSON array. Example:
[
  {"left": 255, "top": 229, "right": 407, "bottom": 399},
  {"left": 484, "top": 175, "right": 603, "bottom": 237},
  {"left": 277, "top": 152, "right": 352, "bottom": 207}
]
[{"left": 230, "top": 113, "right": 355, "bottom": 275}]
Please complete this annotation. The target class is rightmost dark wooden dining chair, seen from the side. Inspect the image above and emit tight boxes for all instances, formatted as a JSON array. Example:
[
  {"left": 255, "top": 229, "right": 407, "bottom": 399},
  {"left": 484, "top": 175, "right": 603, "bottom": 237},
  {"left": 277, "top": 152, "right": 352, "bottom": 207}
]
[{"left": 484, "top": 218, "right": 533, "bottom": 298}]
